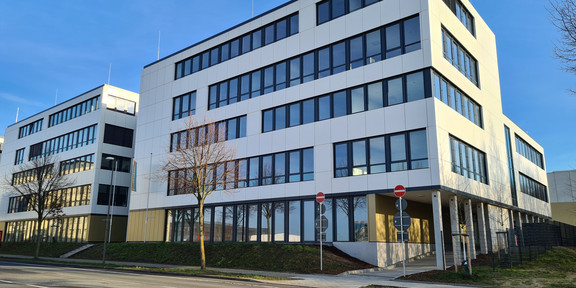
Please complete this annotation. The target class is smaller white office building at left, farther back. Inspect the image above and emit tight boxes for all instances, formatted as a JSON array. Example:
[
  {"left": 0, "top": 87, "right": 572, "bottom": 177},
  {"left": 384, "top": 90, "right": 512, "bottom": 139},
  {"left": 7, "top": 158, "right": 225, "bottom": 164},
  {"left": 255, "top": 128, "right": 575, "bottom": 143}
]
[{"left": 0, "top": 85, "right": 138, "bottom": 242}]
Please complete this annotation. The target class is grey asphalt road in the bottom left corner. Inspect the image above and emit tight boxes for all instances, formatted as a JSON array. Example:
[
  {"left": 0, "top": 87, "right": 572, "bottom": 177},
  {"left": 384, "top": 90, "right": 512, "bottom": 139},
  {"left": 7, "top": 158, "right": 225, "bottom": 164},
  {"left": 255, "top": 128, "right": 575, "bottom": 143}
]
[{"left": 0, "top": 261, "right": 306, "bottom": 288}]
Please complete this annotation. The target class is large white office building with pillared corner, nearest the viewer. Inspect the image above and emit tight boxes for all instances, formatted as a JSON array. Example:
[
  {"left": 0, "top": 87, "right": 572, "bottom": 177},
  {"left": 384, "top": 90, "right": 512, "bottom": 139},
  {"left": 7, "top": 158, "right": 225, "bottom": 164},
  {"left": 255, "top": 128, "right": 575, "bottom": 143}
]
[{"left": 127, "top": 0, "right": 550, "bottom": 267}]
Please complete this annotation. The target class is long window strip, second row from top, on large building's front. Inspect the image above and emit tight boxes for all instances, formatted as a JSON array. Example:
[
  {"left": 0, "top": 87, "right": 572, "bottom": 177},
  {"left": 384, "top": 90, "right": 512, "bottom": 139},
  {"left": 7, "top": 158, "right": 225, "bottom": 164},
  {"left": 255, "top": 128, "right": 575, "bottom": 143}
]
[{"left": 208, "top": 16, "right": 420, "bottom": 109}]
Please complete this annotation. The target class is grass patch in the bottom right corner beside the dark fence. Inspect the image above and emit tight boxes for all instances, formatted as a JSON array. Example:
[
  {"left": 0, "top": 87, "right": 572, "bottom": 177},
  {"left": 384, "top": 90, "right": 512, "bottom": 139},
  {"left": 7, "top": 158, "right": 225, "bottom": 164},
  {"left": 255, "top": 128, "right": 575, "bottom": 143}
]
[{"left": 402, "top": 247, "right": 576, "bottom": 288}]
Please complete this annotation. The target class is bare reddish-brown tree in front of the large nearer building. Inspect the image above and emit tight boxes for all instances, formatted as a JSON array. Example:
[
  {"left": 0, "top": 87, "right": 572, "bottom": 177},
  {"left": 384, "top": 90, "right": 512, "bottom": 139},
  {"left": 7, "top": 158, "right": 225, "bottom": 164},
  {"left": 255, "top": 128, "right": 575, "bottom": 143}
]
[{"left": 161, "top": 117, "right": 238, "bottom": 269}]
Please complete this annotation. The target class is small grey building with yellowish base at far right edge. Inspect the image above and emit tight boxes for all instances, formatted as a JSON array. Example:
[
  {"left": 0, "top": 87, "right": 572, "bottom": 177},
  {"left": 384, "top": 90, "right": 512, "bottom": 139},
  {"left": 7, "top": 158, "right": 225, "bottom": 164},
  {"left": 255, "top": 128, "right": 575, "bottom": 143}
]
[{"left": 548, "top": 170, "right": 576, "bottom": 226}]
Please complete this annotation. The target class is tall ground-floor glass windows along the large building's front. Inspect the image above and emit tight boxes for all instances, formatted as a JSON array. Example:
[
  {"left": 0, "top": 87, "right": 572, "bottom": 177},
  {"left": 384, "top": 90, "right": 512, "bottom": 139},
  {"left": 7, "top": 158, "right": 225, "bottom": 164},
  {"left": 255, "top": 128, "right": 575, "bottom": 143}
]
[{"left": 166, "top": 195, "right": 368, "bottom": 243}]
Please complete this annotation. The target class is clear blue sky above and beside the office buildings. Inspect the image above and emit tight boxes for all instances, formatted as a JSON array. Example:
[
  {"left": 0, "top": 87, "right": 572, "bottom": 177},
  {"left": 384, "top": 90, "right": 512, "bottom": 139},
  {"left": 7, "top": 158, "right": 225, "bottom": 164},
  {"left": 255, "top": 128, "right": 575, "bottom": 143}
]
[{"left": 0, "top": 0, "right": 576, "bottom": 172}]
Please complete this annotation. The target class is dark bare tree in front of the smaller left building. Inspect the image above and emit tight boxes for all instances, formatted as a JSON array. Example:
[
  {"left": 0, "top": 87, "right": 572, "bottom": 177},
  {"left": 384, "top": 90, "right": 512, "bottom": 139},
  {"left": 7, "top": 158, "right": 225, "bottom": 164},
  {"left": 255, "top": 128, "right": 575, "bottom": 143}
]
[{"left": 3, "top": 156, "right": 74, "bottom": 258}]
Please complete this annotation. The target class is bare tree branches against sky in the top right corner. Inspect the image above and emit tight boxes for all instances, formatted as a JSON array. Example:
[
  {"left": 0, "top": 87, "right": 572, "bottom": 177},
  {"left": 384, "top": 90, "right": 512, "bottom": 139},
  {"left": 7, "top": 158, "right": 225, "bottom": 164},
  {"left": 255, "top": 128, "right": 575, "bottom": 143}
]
[{"left": 548, "top": 0, "right": 576, "bottom": 93}]
